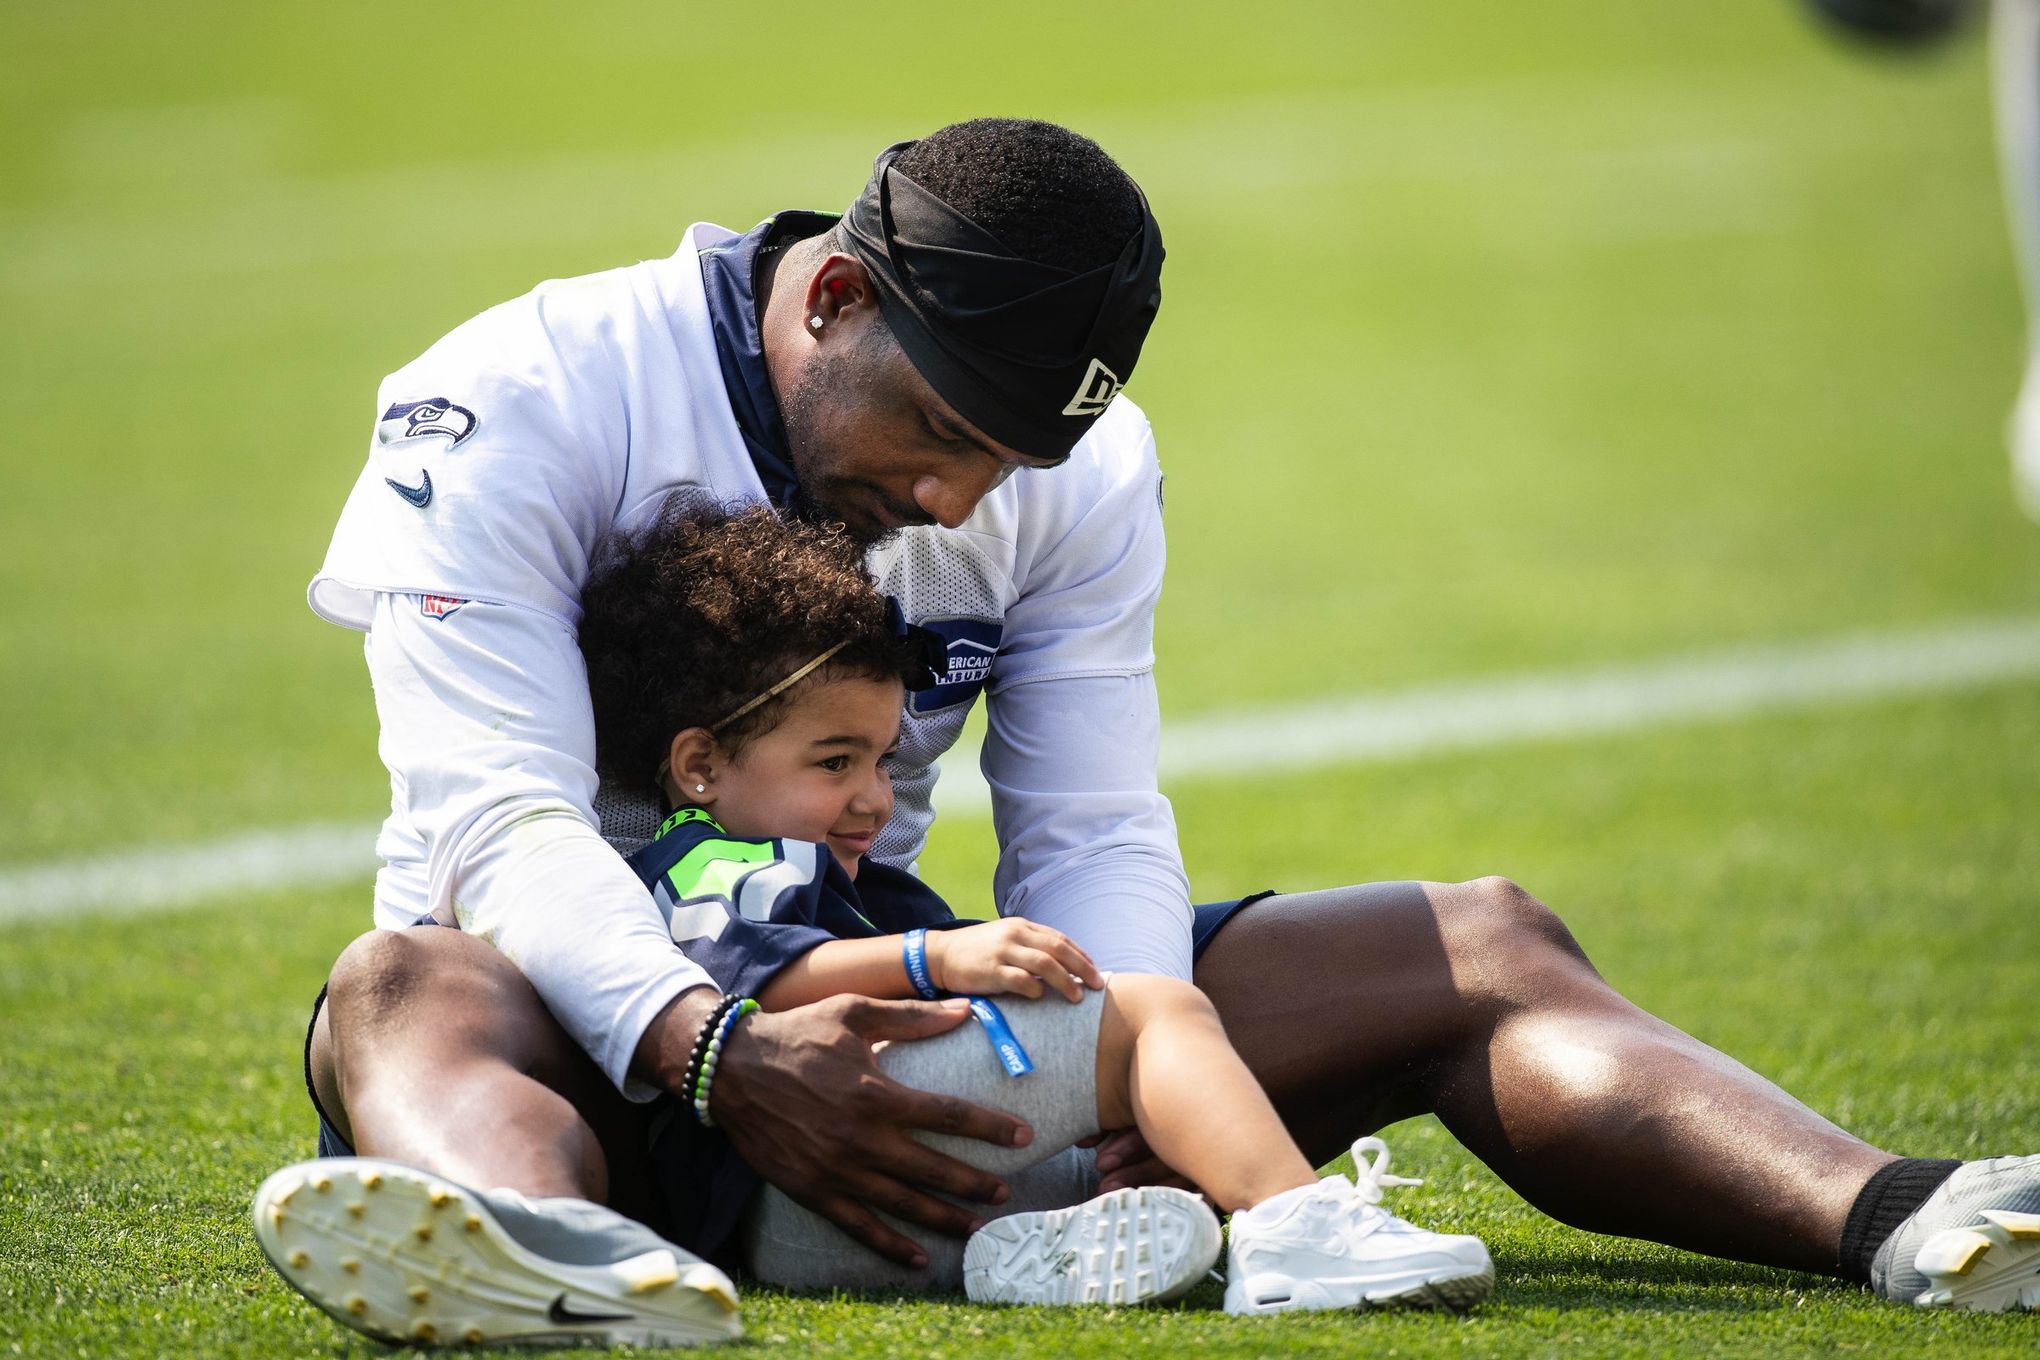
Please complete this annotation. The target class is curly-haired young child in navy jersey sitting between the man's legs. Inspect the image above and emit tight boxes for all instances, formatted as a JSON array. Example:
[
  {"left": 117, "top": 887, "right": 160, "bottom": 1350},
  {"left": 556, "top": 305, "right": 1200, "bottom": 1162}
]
[{"left": 581, "top": 510, "right": 1493, "bottom": 1313}]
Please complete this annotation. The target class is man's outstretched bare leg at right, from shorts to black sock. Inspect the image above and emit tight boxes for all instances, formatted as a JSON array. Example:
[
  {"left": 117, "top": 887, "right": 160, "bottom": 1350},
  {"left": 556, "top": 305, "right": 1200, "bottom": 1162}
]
[{"left": 1191, "top": 879, "right": 1893, "bottom": 1272}]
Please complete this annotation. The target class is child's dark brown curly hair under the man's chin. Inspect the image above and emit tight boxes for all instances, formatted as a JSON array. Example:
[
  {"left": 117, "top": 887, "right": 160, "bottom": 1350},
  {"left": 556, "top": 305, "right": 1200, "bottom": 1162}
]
[{"left": 581, "top": 498, "right": 926, "bottom": 785}]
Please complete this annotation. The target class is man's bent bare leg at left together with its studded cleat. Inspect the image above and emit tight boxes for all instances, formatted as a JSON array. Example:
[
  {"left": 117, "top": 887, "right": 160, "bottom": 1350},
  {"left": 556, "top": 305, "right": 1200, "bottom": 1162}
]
[{"left": 267, "top": 928, "right": 743, "bottom": 1346}]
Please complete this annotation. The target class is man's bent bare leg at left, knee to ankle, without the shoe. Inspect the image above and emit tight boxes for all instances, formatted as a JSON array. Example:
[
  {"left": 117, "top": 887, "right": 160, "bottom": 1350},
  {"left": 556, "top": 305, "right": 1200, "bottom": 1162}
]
[{"left": 312, "top": 928, "right": 647, "bottom": 1217}]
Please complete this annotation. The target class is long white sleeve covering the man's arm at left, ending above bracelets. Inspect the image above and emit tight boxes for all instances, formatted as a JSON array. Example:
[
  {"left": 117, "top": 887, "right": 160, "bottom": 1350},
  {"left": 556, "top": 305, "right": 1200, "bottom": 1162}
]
[{"left": 367, "top": 595, "right": 708, "bottom": 1099}]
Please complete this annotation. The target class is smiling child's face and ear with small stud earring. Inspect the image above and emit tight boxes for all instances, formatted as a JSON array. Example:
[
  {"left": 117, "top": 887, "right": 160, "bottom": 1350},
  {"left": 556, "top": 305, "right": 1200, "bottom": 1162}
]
[{"left": 673, "top": 675, "right": 906, "bottom": 877}]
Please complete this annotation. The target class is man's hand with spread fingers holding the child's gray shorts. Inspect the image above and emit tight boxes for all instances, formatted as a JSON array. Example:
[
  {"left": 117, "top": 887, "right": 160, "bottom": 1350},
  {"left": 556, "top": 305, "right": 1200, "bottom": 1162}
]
[{"left": 710, "top": 995, "right": 1034, "bottom": 1266}]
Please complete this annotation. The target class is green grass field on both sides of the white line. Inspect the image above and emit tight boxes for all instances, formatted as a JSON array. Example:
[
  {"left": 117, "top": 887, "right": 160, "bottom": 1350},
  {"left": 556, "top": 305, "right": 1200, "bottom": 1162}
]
[{"left": 0, "top": 0, "right": 2040, "bottom": 1360}]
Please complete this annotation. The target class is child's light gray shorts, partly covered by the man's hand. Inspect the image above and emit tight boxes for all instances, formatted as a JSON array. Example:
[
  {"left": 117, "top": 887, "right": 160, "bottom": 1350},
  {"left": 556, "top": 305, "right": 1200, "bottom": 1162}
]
[{"left": 736, "top": 991, "right": 1106, "bottom": 1291}]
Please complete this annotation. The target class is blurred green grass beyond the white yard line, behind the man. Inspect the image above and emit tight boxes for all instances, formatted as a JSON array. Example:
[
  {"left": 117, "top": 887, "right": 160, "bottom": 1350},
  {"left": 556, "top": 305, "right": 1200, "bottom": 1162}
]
[{"left": 0, "top": 0, "right": 2040, "bottom": 862}]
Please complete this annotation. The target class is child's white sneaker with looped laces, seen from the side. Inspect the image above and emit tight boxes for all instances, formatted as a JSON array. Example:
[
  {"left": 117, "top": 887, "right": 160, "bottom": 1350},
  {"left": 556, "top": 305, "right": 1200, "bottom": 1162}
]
[{"left": 1226, "top": 1138, "right": 1495, "bottom": 1313}]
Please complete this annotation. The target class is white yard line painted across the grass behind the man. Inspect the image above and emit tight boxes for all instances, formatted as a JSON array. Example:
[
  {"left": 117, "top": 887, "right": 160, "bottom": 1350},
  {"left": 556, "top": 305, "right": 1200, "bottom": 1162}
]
[{"left": 0, "top": 618, "right": 2040, "bottom": 922}]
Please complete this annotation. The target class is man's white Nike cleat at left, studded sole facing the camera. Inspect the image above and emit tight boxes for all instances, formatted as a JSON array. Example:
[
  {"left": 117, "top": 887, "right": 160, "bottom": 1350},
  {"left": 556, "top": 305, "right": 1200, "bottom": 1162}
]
[{"left": 255, "top": 1156, "right": 743, "bottom": 1346}]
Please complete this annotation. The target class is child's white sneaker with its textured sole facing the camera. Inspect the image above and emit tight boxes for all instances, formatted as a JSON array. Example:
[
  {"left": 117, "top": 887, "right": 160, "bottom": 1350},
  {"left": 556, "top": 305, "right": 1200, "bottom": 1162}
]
[{"left": 963, "top": 1185, "right": 1218, "bottom": 1303}]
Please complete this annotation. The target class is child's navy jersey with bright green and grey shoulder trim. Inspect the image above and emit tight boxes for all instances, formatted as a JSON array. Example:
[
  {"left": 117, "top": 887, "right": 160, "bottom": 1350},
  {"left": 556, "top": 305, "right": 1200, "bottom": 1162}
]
[{"left": 630, "top": 807, "right": 965, "bottom": 1011}]
